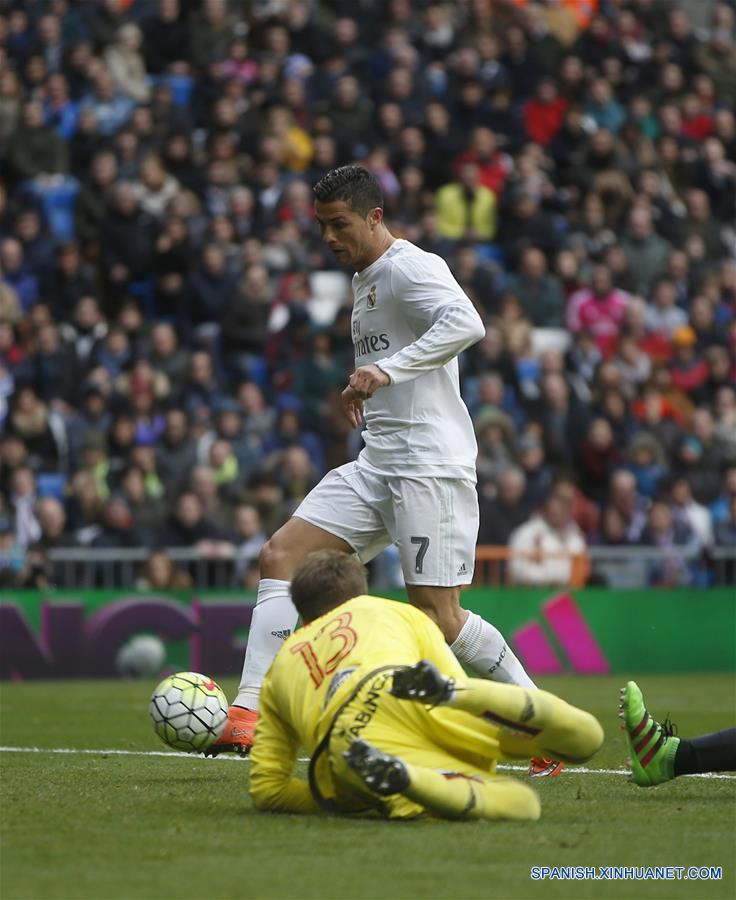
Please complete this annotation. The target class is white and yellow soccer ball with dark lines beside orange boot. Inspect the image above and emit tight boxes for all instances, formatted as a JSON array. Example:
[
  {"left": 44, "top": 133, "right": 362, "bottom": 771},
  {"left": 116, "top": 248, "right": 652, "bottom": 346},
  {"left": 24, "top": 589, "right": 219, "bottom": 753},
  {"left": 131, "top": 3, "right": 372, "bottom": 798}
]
[{"left": 148, "top": 672, "right": 227, "bottom": 753}]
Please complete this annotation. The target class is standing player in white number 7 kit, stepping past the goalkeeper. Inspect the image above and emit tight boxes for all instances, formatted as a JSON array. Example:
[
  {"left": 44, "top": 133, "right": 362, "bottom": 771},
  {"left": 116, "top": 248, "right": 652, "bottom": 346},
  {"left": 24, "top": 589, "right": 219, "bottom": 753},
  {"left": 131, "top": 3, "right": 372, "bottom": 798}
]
[{"left": 210, "top": 166, "right": 552, "bottom": 768}]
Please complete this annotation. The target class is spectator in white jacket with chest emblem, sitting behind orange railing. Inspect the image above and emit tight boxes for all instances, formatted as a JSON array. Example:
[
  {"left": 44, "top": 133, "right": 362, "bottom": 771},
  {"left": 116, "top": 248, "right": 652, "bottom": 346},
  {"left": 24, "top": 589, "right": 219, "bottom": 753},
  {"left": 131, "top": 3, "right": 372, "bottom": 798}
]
[{"left": 509, "top": 479, "right": 586, "bottom": 587}]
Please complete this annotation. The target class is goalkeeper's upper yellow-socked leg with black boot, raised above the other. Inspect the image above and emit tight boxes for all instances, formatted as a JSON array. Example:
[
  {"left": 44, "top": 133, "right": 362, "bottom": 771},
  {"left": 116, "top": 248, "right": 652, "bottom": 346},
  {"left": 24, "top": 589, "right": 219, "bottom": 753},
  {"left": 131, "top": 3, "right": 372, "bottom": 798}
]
[{"left": 391, "top": 660, "right": 603, "bottom": 763}]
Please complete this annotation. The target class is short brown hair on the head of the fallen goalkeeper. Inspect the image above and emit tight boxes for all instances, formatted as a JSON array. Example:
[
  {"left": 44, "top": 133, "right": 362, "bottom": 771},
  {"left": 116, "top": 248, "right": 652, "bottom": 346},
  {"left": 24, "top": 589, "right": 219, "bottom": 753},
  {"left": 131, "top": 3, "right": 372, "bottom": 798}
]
[{"left": 291, "top": 550, "right": 368, "bottom": 622}]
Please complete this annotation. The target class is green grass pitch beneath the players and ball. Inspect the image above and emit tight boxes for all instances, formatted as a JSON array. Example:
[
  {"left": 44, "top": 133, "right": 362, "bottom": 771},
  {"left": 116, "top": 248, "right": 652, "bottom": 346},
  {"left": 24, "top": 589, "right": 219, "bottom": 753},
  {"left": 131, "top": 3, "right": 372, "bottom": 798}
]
[{"left": 0, "top": 675, "right": 736, "bottom": 900}]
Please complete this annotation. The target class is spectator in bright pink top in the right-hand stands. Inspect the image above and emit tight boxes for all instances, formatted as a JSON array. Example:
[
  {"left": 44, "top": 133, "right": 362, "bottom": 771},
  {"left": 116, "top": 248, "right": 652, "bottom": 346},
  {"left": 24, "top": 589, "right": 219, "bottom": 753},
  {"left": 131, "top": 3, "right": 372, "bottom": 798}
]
[{"left": 566, "top": 265, "right": 630, "bottom": 358}]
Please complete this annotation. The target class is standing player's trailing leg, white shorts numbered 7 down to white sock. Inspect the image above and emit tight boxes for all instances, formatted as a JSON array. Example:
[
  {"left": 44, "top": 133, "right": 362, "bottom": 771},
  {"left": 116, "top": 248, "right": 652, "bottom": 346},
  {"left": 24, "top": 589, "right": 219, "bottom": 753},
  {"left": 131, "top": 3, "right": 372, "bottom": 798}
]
[{"left": 387, "top": 478, "right": 534, "bottom": 687}]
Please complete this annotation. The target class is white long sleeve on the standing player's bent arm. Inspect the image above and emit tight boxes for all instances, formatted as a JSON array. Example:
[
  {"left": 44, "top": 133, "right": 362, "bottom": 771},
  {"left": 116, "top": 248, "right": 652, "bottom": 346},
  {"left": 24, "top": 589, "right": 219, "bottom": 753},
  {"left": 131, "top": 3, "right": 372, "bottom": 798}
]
[{"left": 375, "top": 258, "right": 486, "bottom": 384}]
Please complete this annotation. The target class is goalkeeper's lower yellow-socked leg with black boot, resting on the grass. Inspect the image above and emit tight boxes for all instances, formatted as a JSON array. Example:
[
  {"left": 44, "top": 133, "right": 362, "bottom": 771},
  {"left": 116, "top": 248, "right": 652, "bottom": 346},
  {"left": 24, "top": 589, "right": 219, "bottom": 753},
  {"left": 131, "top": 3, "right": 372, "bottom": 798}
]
[{"left": 338, "top": 740, "right": 540, "bottom": 820}]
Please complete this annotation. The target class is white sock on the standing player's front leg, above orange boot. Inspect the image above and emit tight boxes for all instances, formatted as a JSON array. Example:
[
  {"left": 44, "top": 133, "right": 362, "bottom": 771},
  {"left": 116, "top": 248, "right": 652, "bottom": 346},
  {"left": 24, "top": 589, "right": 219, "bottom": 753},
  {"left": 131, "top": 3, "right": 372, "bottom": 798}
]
[{"left": 233, "top": 578, "right": 299, "bottom": 709}]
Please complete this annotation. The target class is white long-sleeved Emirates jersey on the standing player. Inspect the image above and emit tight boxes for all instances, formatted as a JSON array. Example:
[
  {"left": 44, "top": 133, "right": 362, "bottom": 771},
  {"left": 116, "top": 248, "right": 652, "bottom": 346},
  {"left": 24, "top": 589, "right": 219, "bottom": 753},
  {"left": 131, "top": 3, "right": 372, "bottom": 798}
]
[{"left": 352, "top": 240, "right": 485, "bottom": 479}]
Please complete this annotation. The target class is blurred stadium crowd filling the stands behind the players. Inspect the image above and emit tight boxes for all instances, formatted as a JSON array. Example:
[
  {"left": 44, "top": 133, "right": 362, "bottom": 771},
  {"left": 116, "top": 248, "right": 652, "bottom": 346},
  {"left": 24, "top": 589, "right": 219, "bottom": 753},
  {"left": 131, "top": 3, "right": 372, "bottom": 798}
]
[{"left": 0, "top": 0, "right": 736, "bottom": 587}]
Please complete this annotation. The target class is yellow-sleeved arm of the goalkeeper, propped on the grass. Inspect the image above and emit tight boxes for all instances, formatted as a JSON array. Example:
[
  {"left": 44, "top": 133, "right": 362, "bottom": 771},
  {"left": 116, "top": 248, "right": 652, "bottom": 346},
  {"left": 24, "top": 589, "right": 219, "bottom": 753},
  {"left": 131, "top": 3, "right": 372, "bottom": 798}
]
[{"left": 250, "top": 684, "right": 320, "bottom": 813}]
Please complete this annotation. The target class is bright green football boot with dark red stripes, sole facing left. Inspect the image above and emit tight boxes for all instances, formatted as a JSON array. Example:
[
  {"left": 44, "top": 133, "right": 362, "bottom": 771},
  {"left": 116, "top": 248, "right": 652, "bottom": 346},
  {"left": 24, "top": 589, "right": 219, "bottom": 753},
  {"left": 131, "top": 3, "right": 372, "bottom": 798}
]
[{"left": 619, "top": 681, "right": 680, "bottom": 787}]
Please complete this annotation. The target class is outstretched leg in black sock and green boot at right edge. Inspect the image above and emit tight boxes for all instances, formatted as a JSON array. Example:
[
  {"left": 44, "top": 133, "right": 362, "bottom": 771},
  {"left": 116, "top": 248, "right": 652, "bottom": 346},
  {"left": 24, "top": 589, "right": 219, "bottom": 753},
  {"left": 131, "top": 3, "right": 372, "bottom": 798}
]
[{"left": 619, "top": 681, "right": 736, "bottom": 787}]
